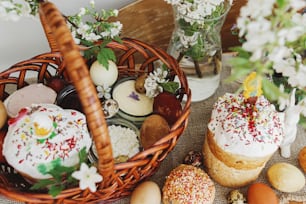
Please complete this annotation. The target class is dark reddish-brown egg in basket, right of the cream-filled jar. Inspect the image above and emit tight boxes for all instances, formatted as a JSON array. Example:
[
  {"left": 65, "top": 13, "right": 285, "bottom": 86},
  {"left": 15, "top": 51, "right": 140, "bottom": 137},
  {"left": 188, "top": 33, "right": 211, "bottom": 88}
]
[{"left": 153, "top": 92, "right": 182, "bottom": 125}]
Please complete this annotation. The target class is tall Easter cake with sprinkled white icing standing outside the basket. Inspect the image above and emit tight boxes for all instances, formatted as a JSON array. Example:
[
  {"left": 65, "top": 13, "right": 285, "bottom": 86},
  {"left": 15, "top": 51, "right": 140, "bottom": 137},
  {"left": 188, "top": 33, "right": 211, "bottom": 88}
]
[{"left": 203, "top": 93, "right": 283, "bottom": 188}]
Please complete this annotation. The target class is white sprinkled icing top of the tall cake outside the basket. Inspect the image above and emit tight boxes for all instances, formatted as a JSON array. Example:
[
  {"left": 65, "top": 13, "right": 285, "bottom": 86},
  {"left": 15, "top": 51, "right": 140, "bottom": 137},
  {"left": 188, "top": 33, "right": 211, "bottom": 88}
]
[{"left": 208, "top": 93, "right": 283, "bottom": 157}]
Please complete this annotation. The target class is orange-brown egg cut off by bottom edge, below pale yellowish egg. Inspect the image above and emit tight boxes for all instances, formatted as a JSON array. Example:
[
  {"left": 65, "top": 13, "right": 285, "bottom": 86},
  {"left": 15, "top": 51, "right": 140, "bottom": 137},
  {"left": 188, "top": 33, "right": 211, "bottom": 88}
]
[{"left": 247, "top": 183, "right": 279, "bottom": 204}]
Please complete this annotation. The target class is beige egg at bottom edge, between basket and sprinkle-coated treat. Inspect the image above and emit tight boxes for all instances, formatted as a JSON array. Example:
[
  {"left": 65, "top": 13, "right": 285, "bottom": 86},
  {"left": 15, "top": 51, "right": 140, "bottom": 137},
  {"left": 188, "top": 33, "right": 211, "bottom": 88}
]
[{"left": 130, "top": 181, "right": 161, "bottom": 204}]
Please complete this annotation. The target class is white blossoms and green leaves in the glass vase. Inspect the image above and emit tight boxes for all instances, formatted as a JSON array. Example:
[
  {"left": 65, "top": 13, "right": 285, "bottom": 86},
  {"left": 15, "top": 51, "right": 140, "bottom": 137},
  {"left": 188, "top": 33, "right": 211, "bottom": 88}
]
[{"left": 165, "top": 0, "right": 232, "bottom": 61}]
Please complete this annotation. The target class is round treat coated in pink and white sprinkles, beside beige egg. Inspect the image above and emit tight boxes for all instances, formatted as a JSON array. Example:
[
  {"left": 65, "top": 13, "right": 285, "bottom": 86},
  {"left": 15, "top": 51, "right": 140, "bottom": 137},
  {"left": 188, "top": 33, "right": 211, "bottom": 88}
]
[{"left": 162, "top": 164, "right": 216, "bottom": 204}]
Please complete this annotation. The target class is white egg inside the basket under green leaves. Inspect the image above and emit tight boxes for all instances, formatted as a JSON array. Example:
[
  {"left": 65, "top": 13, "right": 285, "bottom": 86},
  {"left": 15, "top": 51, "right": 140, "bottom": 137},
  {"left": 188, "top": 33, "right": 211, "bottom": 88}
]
[{"left": 89, "top": 61, "right": 118, "bottom": 86}]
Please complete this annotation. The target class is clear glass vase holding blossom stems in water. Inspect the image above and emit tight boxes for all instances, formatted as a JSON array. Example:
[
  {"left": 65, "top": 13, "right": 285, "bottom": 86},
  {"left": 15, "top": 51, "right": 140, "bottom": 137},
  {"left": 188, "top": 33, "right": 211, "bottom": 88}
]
[{"left": 168, "top": 1, "right": 231, "bottom": 102}]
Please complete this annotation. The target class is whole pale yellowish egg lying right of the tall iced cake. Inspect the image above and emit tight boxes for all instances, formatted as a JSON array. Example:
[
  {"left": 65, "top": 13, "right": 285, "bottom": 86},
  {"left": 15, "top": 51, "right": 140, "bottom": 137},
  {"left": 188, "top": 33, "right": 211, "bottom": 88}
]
[{"left": 267, "top": 162, "right": 305, "bottom": 193}]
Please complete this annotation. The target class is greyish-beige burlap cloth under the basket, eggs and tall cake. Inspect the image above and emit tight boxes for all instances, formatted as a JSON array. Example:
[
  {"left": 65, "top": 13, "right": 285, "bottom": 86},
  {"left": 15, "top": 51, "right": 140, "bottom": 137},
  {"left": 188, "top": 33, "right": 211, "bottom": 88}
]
[{"left": 0, "top": 54, "right": 306, "bottom": 204}]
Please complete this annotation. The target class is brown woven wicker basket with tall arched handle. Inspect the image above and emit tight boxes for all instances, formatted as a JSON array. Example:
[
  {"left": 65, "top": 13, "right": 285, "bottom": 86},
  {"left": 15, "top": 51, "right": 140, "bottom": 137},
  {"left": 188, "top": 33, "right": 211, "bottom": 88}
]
[{"left": 0, "top": 3, "right": 191, "bottom": 203}]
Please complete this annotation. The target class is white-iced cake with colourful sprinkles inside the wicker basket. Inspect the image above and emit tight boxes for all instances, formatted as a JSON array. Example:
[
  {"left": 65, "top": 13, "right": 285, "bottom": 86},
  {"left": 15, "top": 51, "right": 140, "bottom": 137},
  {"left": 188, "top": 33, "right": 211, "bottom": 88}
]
[{"left": 3, "top": 104, "right": 92, "bottom": 179}]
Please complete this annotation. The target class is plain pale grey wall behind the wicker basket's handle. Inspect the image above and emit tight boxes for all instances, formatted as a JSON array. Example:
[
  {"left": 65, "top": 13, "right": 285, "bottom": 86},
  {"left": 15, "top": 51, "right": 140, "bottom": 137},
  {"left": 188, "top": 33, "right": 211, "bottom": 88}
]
[{"left": 0, "top": 0, "right": 136, "bottom": 72}]
